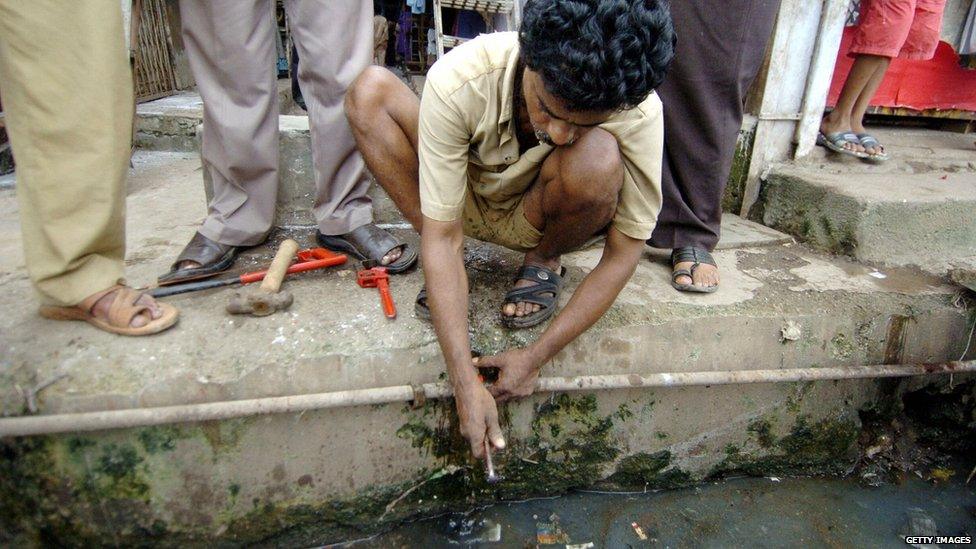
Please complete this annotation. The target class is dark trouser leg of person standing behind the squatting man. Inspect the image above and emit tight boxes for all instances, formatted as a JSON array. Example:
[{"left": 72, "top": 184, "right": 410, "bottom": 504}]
[{"left": 648, "top": 0, "right": 779, "bottom": 250}]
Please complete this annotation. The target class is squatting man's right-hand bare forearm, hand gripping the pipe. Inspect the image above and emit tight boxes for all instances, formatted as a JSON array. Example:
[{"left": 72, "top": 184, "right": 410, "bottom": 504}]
[{"left": 477, "top": 227, "right": 645, "bottom": 401}]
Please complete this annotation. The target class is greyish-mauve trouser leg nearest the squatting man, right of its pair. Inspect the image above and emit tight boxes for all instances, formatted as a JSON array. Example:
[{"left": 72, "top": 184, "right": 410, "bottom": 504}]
[{"left": 285, "top": 0, "right": 373, "bottom": 235}]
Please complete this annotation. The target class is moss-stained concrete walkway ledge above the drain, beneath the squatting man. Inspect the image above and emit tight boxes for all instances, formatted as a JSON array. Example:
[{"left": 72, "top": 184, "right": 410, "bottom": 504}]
[{"left": 0, "top": 152, "right": 974, "bottom": 545}]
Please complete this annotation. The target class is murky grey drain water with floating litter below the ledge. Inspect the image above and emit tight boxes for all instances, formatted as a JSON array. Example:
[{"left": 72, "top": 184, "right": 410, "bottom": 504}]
[{"left": 342, "top": 469, "right": 976, "bottom": 548}]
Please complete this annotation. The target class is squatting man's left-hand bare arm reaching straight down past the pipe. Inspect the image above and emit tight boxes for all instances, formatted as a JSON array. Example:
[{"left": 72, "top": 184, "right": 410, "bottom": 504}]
[{"left": 420, "top": 217, "right": 505, "bottom": 457}]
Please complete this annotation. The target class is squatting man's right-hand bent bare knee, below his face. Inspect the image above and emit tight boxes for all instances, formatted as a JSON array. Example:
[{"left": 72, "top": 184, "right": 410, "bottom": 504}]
[{"left": 558, "top": 128, "right": 624, "bottom": 214}]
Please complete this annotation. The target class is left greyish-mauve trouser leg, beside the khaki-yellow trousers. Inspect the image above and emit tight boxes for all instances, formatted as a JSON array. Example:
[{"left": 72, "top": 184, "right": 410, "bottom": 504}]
[{"left": 180, "top": 0, "right": 280, "bottom": 245}]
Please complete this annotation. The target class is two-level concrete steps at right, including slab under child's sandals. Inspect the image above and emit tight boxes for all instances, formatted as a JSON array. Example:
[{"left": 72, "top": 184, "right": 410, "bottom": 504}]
[{"left": 754, "top": 130, "right": 976, "bottom": 276}]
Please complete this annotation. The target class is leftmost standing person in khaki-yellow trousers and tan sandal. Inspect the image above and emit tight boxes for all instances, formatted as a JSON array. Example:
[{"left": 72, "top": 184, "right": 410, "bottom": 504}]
[{"left": 0, "top": 0, "right": 178, "bottom": 335}]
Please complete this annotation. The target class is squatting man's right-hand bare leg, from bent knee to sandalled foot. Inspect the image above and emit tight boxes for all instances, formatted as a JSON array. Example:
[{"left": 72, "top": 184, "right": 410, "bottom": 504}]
[{"left": 510, "top": 128, "right": 623, "bottom": 316}]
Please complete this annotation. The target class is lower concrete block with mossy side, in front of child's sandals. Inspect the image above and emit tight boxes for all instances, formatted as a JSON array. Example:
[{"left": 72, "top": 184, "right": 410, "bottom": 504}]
[{"left": 762, "top": 166, "right": 976, "bottom": 275}]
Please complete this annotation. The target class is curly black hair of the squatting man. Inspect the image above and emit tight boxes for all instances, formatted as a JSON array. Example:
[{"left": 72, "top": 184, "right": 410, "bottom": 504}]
[{"left": 519, "top": 0, "right": 675, "bottom": 112}]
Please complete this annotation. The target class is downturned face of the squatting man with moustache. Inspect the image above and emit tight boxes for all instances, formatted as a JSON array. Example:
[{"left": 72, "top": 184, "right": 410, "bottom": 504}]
[{"left": 522, "top": 68, "right": 614, "bottom": 147}]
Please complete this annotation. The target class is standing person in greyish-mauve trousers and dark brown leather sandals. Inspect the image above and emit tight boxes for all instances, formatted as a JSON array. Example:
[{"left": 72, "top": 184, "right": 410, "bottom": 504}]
[{"left": 159, "top": 0, "right": 417, "bottom": 284}]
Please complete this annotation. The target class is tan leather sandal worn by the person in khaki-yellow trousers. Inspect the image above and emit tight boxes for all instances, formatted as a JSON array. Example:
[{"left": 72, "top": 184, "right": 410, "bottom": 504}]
[{"left": 39, "top": 285, "right": 180, "bottom": 336}]
